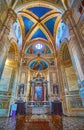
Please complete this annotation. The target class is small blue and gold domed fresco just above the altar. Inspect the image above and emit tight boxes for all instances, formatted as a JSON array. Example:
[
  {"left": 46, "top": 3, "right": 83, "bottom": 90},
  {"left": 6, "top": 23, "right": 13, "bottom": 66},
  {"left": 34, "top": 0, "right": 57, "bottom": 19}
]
[{"left": 30, "top": 60, "right": 48, "bottom": 70}]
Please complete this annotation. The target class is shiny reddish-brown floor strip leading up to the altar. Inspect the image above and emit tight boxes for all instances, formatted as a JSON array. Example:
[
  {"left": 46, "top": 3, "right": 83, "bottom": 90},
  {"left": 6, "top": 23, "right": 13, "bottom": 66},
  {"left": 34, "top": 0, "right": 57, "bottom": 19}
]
[{"left": 16, "top": 115, "right": 63, "bottom": 130}]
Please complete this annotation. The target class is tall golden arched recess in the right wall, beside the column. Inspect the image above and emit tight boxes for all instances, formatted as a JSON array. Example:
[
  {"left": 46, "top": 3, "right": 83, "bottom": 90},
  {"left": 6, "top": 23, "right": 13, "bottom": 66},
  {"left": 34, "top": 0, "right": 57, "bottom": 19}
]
[{"left": 60, "top": 42, "right": 78, "bottom": 94}]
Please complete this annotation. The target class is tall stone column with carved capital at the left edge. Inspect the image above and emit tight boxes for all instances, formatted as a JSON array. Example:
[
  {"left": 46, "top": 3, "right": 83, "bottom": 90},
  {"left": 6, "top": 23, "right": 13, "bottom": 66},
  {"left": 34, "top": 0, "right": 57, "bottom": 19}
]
[{"left": 0, "top": 9, "right": 16, "bottom": 78}]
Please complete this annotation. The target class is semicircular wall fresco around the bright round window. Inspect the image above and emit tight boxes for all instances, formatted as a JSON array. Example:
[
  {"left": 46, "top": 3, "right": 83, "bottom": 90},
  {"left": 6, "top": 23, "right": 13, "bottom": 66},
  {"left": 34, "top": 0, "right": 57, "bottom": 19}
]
[{"left": 25, "top": 44, "right": 52, "bottom": 54}]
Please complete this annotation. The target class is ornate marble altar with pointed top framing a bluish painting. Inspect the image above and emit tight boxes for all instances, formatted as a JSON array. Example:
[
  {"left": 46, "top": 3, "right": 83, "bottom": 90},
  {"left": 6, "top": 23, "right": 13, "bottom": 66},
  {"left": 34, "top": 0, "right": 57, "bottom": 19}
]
[{"left": 27, "top": 73, "right": 50, "bottom": 114}]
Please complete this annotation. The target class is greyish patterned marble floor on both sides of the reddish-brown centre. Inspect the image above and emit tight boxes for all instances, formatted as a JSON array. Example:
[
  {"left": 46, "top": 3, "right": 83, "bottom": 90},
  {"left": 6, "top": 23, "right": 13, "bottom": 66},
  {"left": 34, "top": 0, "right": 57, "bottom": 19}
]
[{"left": 0, "top": 117, "right": 84, "bottom": 130}]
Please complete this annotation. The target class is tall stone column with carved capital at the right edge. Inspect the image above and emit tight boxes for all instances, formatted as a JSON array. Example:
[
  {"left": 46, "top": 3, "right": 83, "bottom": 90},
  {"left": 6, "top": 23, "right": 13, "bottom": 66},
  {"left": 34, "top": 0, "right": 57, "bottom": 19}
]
[{"left": 62, "top": 10, "right": 84, "bottom": 87}]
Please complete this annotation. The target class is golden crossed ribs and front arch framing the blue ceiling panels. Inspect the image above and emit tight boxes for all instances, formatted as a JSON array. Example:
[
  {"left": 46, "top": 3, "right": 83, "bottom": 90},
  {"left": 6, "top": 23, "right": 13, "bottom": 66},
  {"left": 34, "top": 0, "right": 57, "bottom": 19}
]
[{"left": 15, "top": 1, "right": 65, "bottom": 53}]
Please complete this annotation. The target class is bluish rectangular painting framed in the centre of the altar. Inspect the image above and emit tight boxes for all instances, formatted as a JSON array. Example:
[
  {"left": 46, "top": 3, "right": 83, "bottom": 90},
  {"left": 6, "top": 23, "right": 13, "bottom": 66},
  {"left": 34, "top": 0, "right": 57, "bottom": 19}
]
[{"left": 34, "top": 86, "right": 43, "bottom": 101}]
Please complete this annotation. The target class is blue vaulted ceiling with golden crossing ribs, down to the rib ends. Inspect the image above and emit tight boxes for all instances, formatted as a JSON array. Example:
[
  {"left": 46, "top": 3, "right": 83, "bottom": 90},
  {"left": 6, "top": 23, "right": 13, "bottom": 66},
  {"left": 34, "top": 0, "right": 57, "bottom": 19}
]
[{"left": 18, "top": 4, "right": 62, "bottom": 52}]
